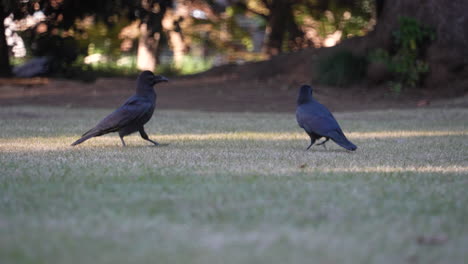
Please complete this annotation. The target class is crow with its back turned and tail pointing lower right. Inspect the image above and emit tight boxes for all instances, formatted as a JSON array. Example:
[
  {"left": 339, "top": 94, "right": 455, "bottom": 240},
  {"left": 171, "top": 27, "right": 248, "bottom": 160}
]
[{"left": 296, "top": 85, "right": 357, "bottom": 150}]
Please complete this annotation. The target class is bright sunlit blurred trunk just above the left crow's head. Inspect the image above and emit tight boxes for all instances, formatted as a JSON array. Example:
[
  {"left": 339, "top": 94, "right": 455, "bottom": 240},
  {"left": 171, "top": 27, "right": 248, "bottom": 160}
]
[{"left": 137, "top": 23, "right": 161, "bottom": 71}]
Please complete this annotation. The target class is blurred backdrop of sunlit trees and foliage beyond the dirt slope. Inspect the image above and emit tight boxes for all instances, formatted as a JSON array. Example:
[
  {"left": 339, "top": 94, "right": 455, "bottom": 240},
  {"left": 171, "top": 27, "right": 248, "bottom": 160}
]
[{"left": 0, "top": 0, "right": 374, "bottom": 75}]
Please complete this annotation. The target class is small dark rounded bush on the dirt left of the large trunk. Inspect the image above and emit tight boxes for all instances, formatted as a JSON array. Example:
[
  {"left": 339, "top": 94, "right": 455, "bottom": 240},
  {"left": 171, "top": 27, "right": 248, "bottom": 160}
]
[{"left": 317, "top": 50, "right": 367, "bottom": 86}]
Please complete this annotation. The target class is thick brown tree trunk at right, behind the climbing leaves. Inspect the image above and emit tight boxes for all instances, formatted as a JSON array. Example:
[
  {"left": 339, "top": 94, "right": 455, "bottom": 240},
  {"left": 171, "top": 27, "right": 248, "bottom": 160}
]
[{"left": 365, "top": 0, "right": 468, "bottom": 87}]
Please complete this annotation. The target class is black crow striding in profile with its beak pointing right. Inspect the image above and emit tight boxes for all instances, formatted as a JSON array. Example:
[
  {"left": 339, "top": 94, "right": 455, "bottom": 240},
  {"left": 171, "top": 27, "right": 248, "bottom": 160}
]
[{"left": 71, "top": 71, "right": 168, "bottom": 146}]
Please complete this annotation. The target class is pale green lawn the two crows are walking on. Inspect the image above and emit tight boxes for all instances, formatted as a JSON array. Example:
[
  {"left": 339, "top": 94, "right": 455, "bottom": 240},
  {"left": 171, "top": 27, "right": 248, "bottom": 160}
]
[{"left": 0, "top": 107, "right": 468, "bottom": 264}]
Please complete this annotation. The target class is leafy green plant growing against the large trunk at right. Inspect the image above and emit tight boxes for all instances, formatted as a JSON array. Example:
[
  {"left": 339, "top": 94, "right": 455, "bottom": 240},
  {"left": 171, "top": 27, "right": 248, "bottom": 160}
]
[{"left": 369, "top": 17, "right": 435, "bottom": 89}]
